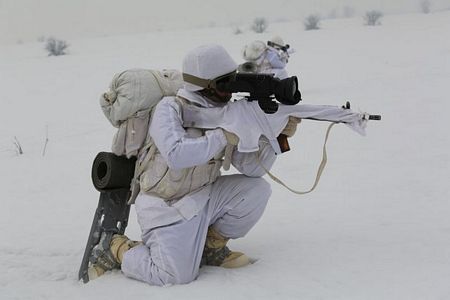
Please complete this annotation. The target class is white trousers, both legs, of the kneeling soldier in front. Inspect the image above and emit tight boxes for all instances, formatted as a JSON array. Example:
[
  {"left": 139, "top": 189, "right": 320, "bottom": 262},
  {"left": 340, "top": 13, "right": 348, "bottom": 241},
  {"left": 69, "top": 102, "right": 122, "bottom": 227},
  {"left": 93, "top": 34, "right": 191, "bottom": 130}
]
[{"left": 122, "top": 175, "right": 270, "bottom": 285}]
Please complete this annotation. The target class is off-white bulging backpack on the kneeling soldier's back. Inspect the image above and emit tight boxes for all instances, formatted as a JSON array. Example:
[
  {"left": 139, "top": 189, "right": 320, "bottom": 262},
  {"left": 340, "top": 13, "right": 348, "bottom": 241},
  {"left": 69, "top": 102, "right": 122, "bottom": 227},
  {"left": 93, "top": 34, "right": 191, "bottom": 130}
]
[{"left": 100, "top": 69, "right": 183, "bottom": 158}]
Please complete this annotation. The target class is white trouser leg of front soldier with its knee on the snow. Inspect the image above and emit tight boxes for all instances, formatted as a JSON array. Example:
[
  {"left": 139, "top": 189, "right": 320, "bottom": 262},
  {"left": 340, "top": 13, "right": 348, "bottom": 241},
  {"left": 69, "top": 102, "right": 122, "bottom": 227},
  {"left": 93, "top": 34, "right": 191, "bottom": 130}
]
[{"left": 122, "top": 209, "right": 208, "bottom": 285}]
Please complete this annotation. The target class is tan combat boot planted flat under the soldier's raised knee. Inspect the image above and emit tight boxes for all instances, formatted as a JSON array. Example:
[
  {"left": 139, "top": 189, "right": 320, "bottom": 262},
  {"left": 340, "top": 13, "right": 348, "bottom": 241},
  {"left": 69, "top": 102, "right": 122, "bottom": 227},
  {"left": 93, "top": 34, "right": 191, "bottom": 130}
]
[{"left": 202, "top": 227, "right": 250, "bottom": 268}]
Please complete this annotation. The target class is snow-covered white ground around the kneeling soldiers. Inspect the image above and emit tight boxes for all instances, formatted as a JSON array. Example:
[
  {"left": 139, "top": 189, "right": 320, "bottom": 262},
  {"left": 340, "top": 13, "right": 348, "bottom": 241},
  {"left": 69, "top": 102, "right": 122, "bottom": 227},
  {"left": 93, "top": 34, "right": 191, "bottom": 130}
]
[{"left": 0, "top": 11, "right": 450, "bottom": 300}]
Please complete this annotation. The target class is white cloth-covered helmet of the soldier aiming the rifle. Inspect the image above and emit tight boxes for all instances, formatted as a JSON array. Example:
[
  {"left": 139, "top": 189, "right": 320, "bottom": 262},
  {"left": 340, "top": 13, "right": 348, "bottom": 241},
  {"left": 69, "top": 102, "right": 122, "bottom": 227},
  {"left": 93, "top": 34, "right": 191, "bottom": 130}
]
[{"left": 183, "top": 45, "right": 238, "bottom": 92}]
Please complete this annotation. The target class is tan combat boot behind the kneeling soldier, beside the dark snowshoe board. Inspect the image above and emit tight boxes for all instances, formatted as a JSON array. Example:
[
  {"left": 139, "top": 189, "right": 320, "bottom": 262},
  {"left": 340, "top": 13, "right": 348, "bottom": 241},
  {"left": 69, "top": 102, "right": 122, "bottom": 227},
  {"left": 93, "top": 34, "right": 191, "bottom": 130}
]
[{"left": 88, "top": 234, "right": 141, "bottom": 280}]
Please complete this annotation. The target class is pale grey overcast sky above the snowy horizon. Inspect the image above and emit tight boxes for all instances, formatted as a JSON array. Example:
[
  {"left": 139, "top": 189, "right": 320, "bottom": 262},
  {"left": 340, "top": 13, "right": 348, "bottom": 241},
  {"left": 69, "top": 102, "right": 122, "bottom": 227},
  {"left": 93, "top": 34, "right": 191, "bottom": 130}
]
[{"left": 0, "top": 0, "right": 450, "bottom": 44}]
